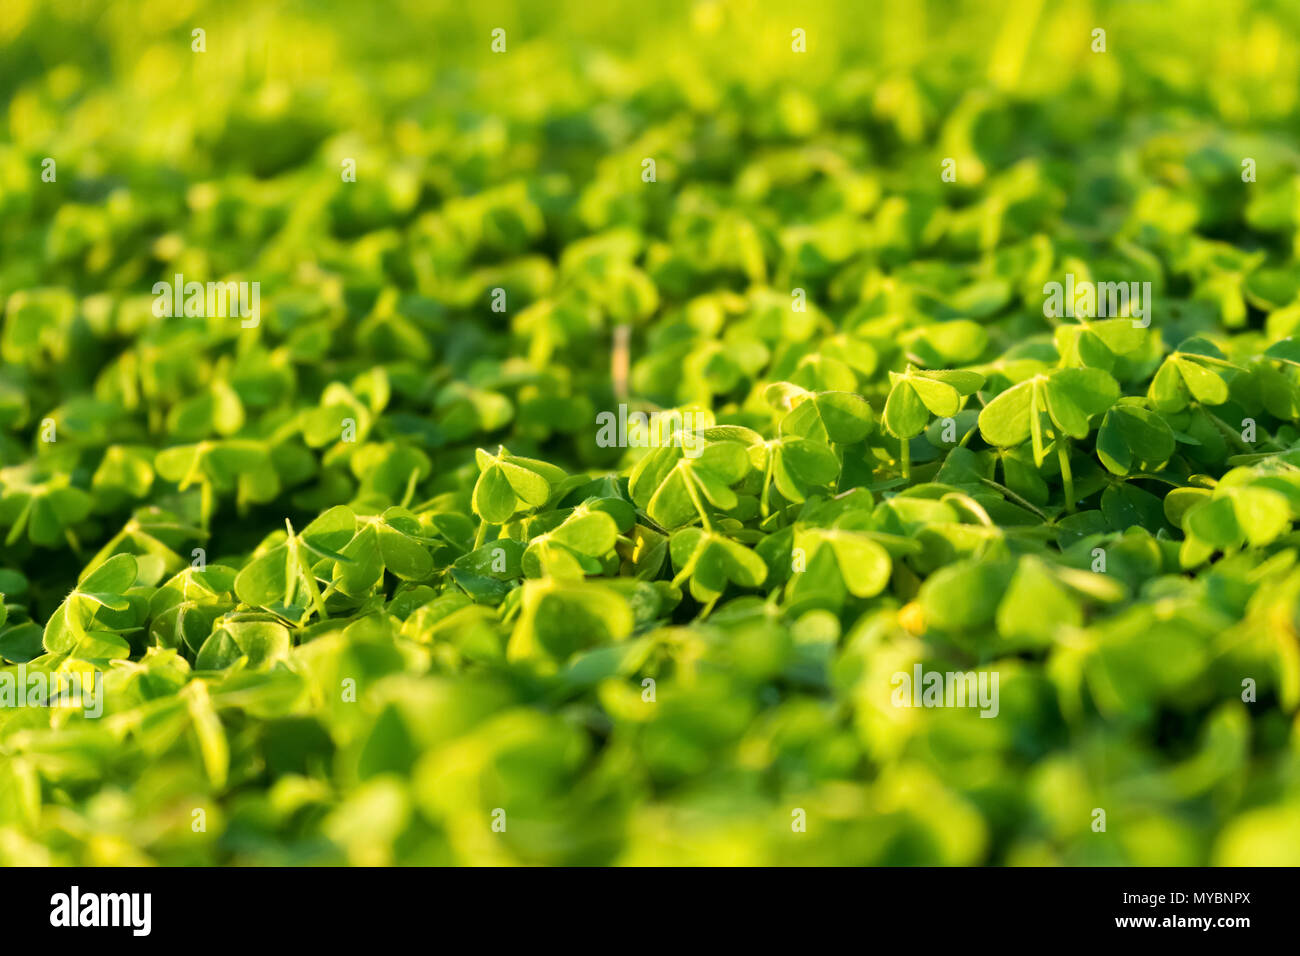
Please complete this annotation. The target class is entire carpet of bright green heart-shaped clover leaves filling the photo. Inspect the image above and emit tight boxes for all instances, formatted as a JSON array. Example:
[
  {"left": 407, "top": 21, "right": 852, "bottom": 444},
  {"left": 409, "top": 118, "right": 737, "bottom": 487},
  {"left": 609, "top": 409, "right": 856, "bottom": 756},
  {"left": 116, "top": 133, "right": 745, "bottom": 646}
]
[{"left": 0, "top": 0, "right": 1300, "bottom": 864}]
